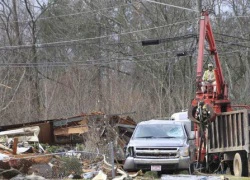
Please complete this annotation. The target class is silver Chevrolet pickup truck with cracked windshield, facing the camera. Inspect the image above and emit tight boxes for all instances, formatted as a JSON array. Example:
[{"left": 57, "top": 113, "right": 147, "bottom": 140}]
[{"left": 123, "top": 114, "right": 195, "bottom": 172}]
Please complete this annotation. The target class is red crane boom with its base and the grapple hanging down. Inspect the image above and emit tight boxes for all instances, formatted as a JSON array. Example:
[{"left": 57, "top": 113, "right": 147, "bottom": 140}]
[{"left": 188, "top": 11, "right": 232, "bottom": 166}]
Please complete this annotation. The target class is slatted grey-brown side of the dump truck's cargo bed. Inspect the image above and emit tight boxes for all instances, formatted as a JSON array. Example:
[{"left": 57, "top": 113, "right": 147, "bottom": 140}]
[{"left": 208, "top": 109, "right": 250, "bottom": 153}]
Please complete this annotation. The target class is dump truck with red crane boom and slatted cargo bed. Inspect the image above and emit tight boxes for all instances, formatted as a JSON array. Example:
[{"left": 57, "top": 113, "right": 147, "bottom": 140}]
[{"left": 188, "top": 10, "right": 250, "bottom": 177}]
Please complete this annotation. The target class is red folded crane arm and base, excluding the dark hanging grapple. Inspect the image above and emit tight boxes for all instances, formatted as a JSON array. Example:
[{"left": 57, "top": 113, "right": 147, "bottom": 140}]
[{"left": 189, "top": 11, "right": 232, "bottom": 124}]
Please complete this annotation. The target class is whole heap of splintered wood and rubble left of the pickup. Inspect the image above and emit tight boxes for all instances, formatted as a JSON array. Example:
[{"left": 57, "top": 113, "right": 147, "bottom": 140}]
[{"left": 0, "top": 112, "right": 136, "bottom": 179}]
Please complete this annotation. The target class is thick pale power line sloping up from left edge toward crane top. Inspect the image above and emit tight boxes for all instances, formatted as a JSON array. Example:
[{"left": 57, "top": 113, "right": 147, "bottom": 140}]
[{"left": 0, "top": 21, "right": 193, "bottom": 50}]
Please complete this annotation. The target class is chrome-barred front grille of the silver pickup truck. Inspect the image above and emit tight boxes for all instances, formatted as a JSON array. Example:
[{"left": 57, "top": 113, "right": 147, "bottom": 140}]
[{"left": 135, "top": 147, "right": 179, "bottom": 159}]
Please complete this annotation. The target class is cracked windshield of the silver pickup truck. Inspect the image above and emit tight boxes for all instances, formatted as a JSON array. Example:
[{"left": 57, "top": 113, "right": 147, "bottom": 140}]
[{"left": 134, "top": 124, "right": 184, "bottom": 138}]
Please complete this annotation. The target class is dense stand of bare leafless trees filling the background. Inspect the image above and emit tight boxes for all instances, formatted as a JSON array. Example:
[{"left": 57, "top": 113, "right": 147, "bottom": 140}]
[{"left": 0, "top": 0, "right": 250, "bottom": 123}]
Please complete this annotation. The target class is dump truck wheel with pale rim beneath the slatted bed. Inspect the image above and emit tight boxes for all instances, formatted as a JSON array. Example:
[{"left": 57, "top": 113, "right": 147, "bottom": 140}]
[{"left": 233, "top": 153, "right": 248, "bottom": 177}]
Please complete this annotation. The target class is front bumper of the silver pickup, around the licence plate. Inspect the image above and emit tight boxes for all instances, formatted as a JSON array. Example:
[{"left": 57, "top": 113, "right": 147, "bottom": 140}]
[{"left": 123, "top": 156, "right": 190, "bottom": 171}]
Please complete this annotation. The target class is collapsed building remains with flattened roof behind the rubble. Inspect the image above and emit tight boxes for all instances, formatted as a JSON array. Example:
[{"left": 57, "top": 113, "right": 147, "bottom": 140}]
[{"left": 0, "top": 112, "right": 136, "bottom": 150}]
